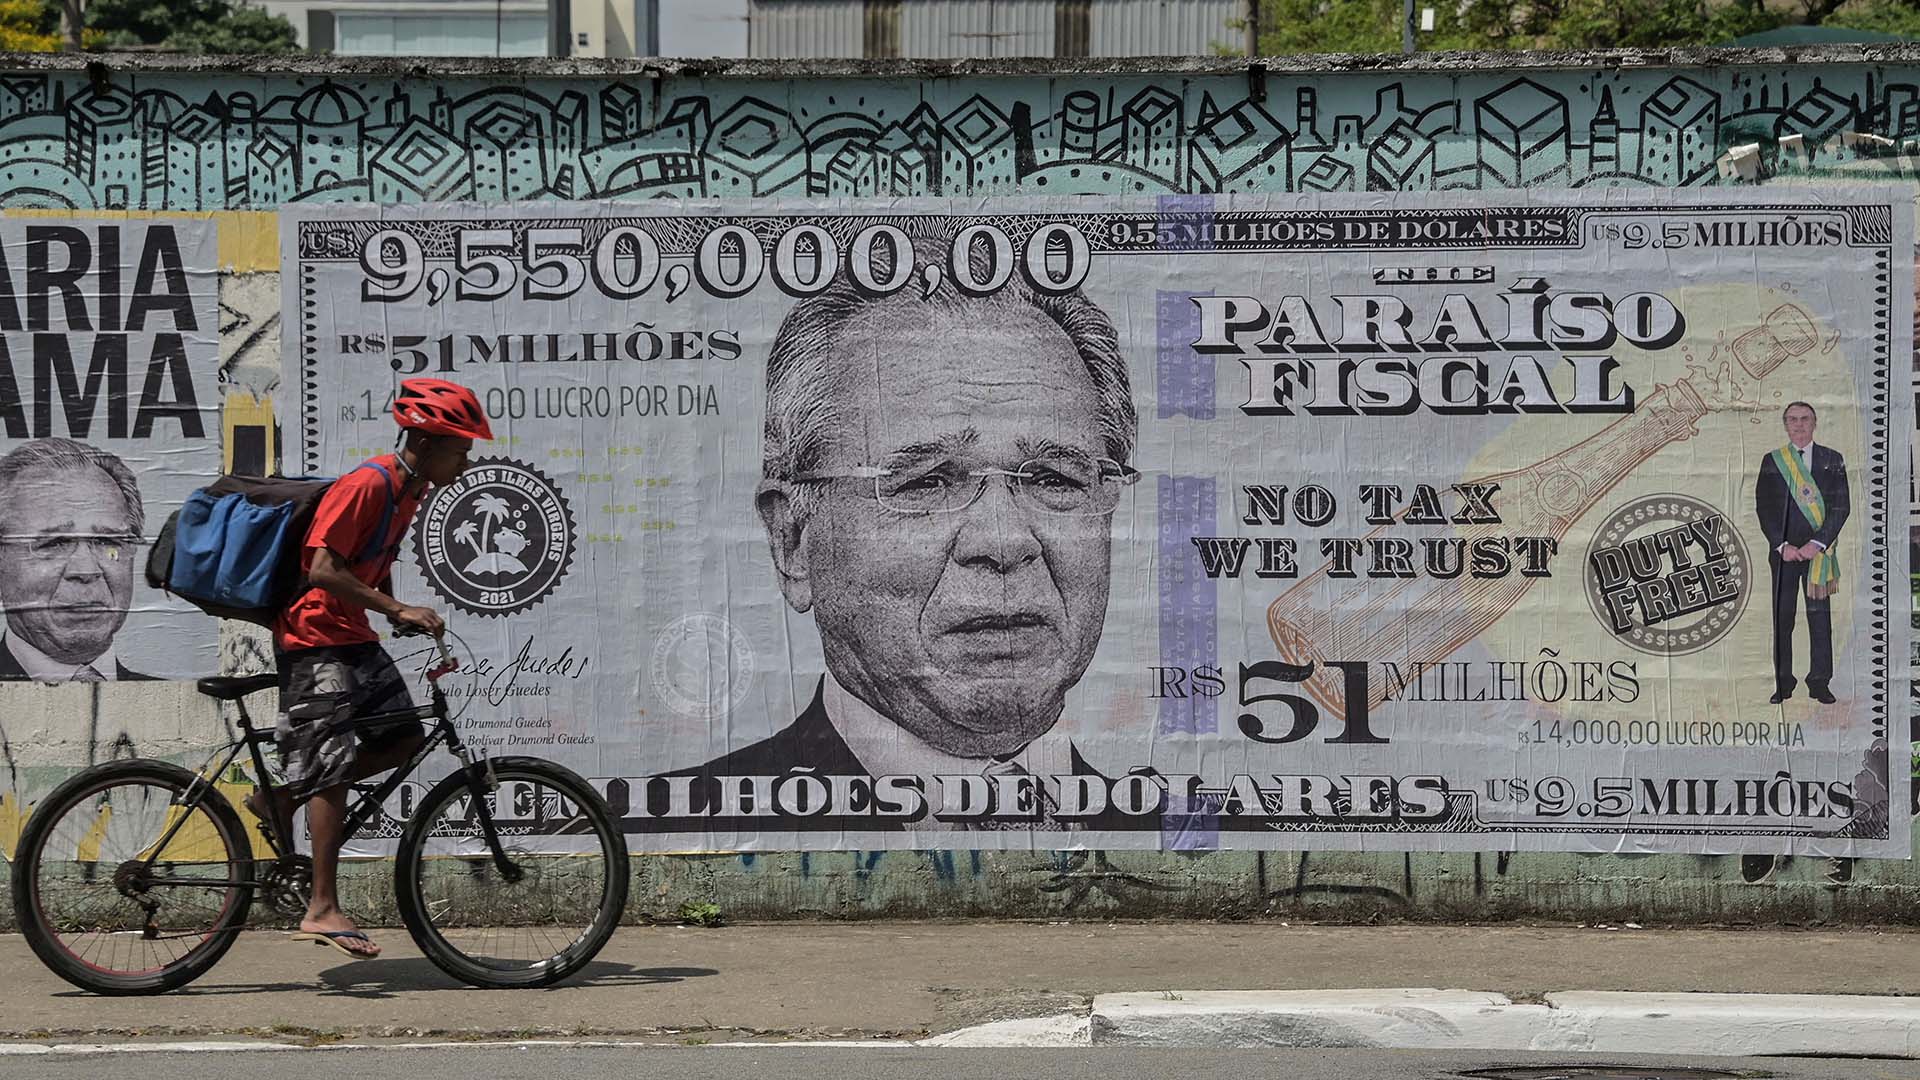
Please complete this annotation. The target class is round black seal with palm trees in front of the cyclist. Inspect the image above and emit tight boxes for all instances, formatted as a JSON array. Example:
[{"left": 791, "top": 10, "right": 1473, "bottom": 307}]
[{"left": 413, "top": 457, "right": 576, "bottom": 617}]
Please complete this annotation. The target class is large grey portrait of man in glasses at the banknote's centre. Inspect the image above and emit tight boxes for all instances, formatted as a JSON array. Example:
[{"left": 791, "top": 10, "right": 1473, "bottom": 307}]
[{"left": 675, "top": 228, "right": 1139, "bottom": 822}]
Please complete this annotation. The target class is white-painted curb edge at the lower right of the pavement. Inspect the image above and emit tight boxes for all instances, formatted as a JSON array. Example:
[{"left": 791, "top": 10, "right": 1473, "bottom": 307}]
[{"left": 1090, "top": 990, "right": 1920, "bottom": 1057}]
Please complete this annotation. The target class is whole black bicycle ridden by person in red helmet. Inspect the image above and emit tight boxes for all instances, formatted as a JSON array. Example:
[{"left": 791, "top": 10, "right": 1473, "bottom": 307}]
[{"left": 13, "top": 638, "right": 628, "bottom": 995}]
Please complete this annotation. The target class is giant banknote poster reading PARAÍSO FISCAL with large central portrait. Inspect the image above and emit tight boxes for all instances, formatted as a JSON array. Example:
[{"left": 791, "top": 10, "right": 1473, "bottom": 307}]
[{"left": 282, "top": 188, "right": 1914, "bottom": 857}]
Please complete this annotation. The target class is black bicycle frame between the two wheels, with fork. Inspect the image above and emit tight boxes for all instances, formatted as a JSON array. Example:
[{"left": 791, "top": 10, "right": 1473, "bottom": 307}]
[{"left": 134, "top": 644, "right": 522, "bottom": 890}]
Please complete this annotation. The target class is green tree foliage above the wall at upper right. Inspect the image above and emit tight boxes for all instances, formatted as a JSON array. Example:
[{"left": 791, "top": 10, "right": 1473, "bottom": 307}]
[{"left": 1223, "top": 0, "right": 1920, "bottom": 56}]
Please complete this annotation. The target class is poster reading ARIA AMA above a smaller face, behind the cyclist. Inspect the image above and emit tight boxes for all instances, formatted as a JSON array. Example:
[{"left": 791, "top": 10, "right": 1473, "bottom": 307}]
[{"left": 0, "top": 217, "right": 223, "bottom": 680}]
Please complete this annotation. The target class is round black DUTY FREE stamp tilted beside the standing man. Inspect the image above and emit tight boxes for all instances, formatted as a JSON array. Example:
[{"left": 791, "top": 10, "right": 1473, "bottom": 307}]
[{"left": 1586, "top": 494, "right": 1753, "bottom": 655}]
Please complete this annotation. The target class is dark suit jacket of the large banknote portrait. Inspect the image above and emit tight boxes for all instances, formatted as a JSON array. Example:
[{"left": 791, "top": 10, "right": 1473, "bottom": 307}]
[{"left": 641, "top": 680, "right": 1160, "bottom": 832}]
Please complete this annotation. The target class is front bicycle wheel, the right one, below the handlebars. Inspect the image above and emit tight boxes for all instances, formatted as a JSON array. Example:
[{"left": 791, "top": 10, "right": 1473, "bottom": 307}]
[{"left": 394, "top": 757, "right": 628, "bottom": 988}]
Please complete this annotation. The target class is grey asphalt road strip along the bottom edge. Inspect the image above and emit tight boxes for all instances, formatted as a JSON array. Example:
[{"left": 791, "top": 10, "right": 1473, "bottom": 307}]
[{"left": 0, "top": 1045, "right": 1920, "bottom": 1080}]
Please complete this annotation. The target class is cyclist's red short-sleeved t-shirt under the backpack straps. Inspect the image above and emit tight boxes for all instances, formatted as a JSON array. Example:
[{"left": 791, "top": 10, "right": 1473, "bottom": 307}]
[{"left": 273, "top": 454, "right": 420, "bottom": 651}]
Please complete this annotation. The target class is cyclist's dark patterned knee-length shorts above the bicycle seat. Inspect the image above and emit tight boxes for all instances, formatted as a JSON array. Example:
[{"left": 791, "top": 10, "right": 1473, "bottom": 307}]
[{"left": 275, "top": 642, "right": 422, "bottom": 798}]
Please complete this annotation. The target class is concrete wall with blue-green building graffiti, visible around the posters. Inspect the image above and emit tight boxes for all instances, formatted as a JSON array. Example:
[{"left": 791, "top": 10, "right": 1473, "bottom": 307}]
[{"left": 0, "top": 48, "right": 1920, "bottom": 922}]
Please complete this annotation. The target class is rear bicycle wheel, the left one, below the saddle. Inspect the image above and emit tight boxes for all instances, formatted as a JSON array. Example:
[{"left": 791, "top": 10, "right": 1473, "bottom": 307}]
[{"left": 13, "top": 761, "right": 253, "bottom": 994}]
